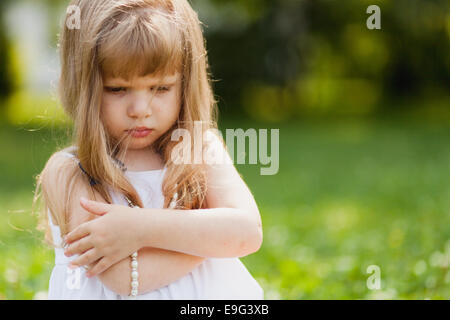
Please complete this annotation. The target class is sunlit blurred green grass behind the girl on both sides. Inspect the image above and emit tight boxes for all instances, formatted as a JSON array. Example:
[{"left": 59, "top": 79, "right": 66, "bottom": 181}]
[{"left": 0, "top": 118, "right": 450, "bottom": 299}]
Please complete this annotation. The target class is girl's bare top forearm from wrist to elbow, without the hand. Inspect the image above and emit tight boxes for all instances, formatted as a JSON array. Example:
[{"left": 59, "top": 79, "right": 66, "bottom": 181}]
[{"left": 136, "top": 208, "right": 262, "bottom": 258}]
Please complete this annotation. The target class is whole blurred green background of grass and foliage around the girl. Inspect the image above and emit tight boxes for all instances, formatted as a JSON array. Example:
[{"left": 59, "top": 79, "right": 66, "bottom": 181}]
[{"left": 0, "top": 0, "right": 450, "bottom": 299}]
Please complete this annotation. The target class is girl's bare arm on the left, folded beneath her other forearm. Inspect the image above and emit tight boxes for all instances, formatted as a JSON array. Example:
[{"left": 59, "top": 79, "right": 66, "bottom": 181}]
[{"left": 43, "top": 154, "right": 204, "bottom": 294}]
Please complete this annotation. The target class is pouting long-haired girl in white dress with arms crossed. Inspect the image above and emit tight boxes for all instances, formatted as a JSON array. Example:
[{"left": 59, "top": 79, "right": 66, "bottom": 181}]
[{"left": 34, "top": 0, "right": 263, "bottom": 299}]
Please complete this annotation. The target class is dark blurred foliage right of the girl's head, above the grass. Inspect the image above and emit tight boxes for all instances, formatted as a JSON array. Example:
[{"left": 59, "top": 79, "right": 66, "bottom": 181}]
[{"left": 193, "top": 0, "right": 450, "bottom": 121}]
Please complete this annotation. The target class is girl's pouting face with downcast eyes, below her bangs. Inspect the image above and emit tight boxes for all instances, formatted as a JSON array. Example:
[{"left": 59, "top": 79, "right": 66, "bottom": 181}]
[{"left": 101, "top": 72, "right": 181, "bottom": 150}]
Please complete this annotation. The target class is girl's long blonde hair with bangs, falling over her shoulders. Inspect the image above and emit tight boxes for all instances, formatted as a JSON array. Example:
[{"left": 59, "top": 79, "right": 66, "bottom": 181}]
[{"left": 33, "top": 0, "right": 223, "bottom": 245}]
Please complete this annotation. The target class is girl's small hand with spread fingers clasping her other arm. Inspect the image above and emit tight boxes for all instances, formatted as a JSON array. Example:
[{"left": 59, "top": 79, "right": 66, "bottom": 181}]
[{"left": 64, "top": 198, "right": 140, "bottom": 277}]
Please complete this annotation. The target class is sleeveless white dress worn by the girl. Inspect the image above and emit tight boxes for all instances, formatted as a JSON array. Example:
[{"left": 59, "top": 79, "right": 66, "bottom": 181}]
[{"left": 48, "top": 151, "right": 264, "bottom": 300}]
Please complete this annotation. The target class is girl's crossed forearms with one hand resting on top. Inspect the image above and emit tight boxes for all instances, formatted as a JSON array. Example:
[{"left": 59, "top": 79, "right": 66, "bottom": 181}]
[{"left": 66, "top": 202, "right": 261, "bottom": 294}]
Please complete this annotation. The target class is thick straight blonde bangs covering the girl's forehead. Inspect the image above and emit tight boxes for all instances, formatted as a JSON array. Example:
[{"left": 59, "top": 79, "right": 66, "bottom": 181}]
[{"left": 98, "top": 10, "right": 183, "bottom": 80}]
